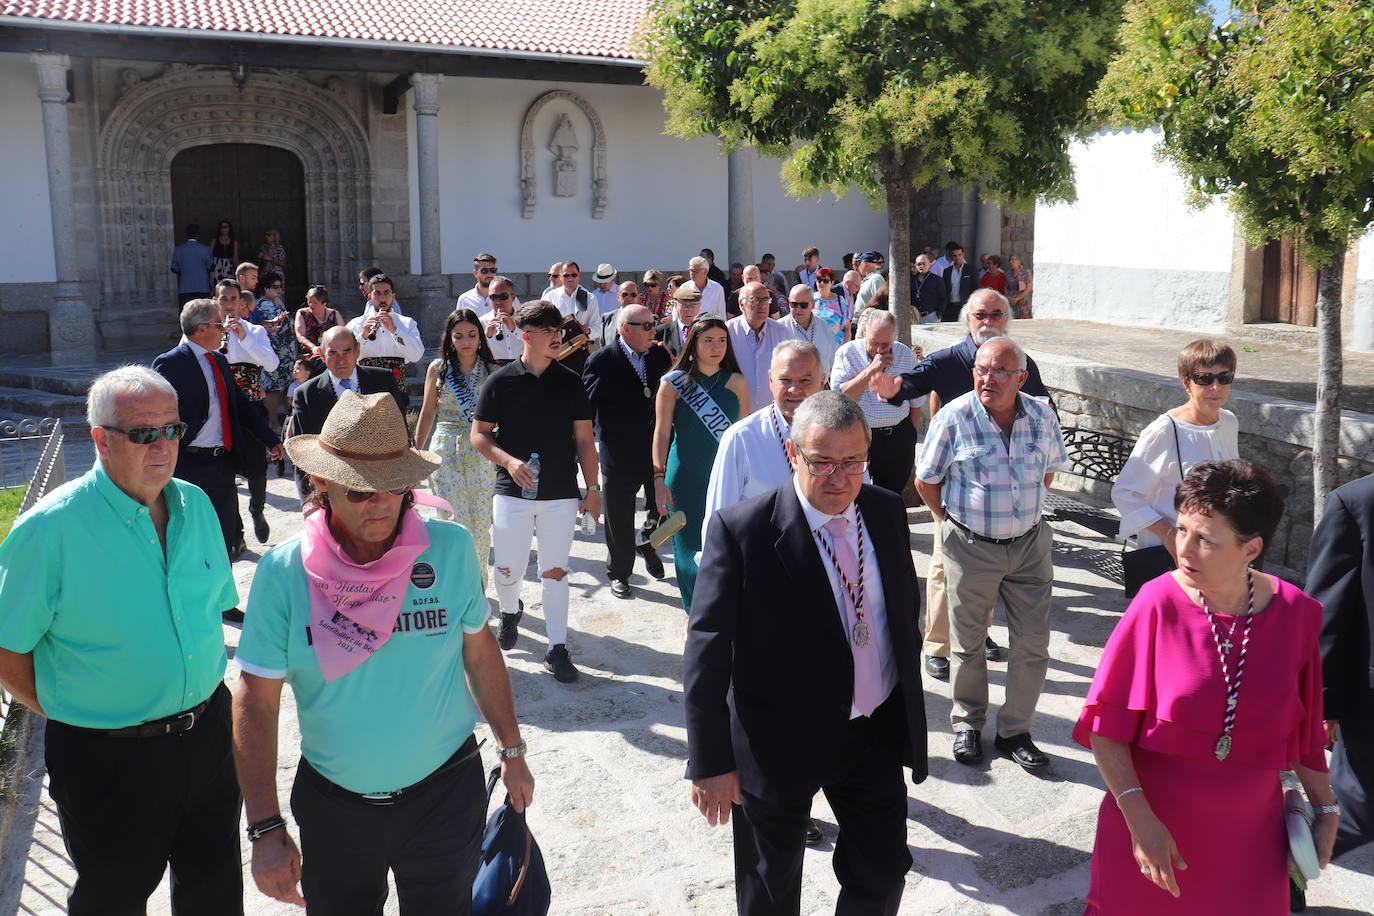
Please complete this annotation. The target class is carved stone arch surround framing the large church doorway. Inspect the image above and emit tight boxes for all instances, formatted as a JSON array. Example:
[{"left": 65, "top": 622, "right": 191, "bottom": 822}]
[{"left": 96, "top": 65, "right": 375, "bottom": 308}]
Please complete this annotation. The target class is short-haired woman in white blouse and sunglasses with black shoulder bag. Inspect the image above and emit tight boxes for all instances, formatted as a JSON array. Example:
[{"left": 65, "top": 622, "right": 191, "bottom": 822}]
[{"left": 1112, "top": 338, "right": 1241, "bottom": 597}]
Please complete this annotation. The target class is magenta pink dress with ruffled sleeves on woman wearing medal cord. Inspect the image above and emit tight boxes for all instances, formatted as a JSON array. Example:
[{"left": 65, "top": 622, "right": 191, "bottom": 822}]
[{"left": 1073, "top": 573, "right": 1326, "bottom": 916}]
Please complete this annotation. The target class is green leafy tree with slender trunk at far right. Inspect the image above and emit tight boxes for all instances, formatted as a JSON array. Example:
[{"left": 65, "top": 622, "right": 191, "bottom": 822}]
[{"left": 1094, "top": 0, "right": 1374, "bottom": 518}]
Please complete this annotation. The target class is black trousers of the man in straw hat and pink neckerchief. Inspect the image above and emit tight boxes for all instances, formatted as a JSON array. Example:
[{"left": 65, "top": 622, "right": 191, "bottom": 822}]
[{"left": 291, "top": 737, "right": 486, "bottom": 916}]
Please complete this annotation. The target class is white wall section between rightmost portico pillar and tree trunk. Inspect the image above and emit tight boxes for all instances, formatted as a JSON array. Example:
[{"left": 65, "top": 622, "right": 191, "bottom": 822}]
[{"left": 752, "top": 155, "right": 888, "bottom": 271}]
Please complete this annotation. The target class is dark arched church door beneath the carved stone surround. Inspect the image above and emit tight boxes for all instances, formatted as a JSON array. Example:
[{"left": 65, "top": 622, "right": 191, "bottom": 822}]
[{"left": 172, "top": 143, "right": 311, "bottom": 309}]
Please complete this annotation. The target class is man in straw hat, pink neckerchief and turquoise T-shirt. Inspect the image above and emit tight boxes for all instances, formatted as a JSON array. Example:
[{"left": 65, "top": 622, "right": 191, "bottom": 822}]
[{"left": 234, "top": 391, "right": 534, "bottom": 913}]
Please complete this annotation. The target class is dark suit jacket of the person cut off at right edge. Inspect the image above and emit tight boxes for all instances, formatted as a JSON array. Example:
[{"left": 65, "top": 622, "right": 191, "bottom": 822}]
[{"left": 1307, "top": 474, "right": 1374, "bottom": 722}]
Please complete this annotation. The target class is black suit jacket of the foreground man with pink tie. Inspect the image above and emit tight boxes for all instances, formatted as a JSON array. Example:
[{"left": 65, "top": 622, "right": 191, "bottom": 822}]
[{"left": 683, "top": 483, "right": 926, "bottom": 798}]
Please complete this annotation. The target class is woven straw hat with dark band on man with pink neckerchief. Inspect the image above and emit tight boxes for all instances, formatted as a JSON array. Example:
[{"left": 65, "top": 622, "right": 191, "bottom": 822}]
[{"left": 286, "top": 391, "right": 442, "bottom": 493}]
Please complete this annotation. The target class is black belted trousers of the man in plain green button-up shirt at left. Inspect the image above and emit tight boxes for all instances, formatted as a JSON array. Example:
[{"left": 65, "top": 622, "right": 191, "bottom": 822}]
[{"left": 47, "top": 684, "right": 243, "bottom": 916}]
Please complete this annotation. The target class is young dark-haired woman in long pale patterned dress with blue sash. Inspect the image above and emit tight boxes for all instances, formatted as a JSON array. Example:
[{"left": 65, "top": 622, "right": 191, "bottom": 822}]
[{"left": 415, "top": 309, "right": 496, "bottom": 586}]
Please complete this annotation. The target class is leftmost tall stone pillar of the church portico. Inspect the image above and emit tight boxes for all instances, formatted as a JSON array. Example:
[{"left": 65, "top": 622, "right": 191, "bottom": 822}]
[{"left": 30, "top": 52, "right": 96, "bottom": 365}]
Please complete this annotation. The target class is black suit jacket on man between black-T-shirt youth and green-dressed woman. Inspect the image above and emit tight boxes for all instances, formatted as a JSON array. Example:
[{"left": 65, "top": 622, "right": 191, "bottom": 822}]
[{"left": 583, "top": 338, "right": 672, "bottom": 479}]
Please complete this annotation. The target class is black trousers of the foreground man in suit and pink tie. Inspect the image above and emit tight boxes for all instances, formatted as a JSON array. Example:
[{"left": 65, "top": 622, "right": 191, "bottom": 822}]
[{"left": 731, "top": 687, "right": 911, "bottom": 916}]
